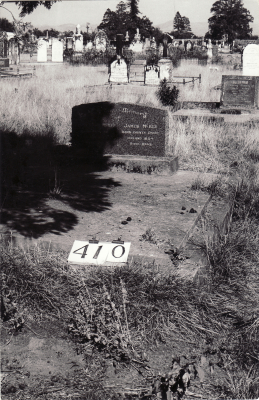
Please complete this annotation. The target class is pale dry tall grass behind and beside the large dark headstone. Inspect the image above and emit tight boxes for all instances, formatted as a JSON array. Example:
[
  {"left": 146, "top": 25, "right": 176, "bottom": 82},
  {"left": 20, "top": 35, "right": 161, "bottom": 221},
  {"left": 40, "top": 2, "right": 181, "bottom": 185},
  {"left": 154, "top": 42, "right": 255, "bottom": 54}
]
[{"left": 0, "top": 64, "right": 259, "bottom": 172}]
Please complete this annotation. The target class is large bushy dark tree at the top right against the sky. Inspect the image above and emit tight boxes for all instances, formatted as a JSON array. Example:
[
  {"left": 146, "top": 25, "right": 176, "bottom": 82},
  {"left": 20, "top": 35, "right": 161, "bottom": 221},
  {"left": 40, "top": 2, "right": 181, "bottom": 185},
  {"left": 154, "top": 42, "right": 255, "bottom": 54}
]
[{"left": 208, "top": 0, "right": 254, "bottom": 42}]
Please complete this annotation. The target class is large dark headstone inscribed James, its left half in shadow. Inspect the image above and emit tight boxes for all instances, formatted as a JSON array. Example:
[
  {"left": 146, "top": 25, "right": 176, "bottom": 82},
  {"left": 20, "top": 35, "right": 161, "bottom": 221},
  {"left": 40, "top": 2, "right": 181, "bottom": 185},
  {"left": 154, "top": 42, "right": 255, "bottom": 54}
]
[{"left": 71, "top": 102, "right": 168, "bottom": 157}]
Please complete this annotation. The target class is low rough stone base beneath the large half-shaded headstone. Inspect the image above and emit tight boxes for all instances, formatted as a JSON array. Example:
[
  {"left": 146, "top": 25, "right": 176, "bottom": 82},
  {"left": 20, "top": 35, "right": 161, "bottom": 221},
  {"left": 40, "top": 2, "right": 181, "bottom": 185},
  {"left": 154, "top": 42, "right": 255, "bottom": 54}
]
[{"left": 106, "top": 155, "right": 179, "bottom": 175}]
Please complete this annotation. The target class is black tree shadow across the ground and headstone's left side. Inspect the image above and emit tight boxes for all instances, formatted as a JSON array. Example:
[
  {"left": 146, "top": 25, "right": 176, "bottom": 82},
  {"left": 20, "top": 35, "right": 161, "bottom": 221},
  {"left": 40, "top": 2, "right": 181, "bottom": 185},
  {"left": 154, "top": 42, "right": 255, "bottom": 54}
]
[{"left": 0, "top": 103, "right": 123, "bottom": 238}]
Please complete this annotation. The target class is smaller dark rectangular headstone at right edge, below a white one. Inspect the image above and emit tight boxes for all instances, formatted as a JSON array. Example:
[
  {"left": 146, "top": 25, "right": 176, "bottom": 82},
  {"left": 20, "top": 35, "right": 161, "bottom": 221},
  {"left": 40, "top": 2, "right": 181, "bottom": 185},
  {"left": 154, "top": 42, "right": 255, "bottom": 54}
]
[{"left": 220, "top": 75, "right": 257, "bottom": 108}]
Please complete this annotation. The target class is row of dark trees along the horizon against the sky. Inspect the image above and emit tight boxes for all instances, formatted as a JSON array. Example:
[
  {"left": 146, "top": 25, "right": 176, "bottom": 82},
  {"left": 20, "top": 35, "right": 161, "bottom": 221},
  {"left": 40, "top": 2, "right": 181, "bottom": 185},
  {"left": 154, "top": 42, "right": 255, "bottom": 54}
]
[{"left": 0, "top": 0, "right": 256, "bottom": 42}]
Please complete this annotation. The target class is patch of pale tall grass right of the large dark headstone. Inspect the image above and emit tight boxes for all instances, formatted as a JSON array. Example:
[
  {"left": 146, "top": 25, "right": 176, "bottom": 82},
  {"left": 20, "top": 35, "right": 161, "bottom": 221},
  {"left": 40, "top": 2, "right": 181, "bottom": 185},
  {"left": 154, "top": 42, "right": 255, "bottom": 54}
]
[{"left": 169, "top": 115, "right": 259, "bottom": 173}]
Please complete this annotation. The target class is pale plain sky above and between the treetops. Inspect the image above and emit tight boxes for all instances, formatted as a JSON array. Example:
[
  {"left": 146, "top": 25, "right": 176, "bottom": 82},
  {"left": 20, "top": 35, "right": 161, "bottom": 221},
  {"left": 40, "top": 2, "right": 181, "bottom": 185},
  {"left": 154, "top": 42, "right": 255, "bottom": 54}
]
[{"left": 0, "top": 0, "right": 259, "bottom": 34}]
